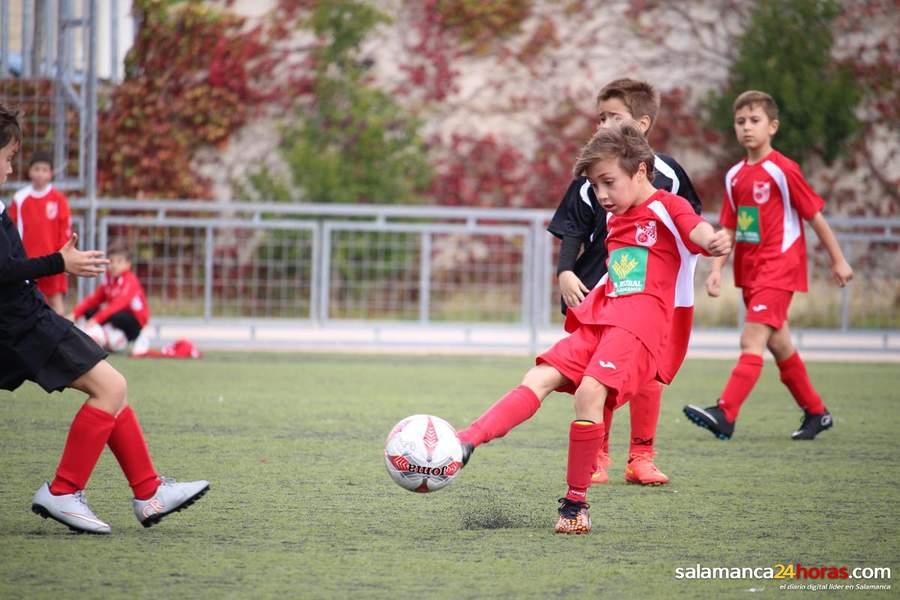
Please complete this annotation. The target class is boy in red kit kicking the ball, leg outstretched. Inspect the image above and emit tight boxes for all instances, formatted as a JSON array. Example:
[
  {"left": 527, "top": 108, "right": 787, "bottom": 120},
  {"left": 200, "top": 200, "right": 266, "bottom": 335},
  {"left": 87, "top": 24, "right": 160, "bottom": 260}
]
[{"left": 460, "top": 123, "right": 731, "bottom": 534}]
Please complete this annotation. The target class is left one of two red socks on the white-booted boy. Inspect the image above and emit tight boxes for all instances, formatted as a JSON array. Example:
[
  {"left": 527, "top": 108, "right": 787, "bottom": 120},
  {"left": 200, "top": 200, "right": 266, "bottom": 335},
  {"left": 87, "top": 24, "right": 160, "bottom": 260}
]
[{"left": 50, "top": 404, "right": 116, "bottom": 495}]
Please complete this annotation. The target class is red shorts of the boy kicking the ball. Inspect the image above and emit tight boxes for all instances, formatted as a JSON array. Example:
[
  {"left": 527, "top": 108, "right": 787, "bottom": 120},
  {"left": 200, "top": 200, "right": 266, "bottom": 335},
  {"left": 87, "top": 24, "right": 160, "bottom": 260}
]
[{"left": 535, "top": 325, "right": 657, "bottom": 406}]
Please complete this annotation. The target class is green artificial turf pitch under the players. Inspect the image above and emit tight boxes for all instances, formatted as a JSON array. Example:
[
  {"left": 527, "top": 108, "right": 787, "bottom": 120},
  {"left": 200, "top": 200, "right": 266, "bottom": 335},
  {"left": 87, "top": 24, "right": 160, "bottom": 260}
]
[{"left": 0, "top": 353, "right": 900, "bottom": 600}]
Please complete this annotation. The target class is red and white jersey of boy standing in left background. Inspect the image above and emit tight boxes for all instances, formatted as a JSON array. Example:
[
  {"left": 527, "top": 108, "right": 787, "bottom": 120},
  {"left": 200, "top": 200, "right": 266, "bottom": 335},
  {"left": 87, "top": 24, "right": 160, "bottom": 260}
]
[{"left": 9, "top": 185, "right": 72, "bottom": 257}]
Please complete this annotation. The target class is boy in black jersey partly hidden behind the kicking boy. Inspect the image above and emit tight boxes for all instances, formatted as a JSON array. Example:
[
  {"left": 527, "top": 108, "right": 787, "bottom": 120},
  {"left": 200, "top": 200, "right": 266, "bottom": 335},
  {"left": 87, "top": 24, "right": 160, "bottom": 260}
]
[{"left": 547, "top": 78, "right": 702, "bottom": 485}]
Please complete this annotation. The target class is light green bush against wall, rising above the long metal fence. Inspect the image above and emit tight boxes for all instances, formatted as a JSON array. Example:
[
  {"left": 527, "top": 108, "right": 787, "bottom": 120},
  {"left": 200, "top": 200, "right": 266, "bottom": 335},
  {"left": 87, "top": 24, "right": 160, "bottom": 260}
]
[{"left": 262, "top": 0, "right": 430, "bottom": 203}]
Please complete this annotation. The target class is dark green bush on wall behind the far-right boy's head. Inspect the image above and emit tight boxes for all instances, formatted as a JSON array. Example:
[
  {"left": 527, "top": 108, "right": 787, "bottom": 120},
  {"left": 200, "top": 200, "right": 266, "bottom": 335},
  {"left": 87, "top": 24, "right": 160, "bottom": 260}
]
[{"left": 709, "top": 0, "right": 862, "bottom": 163}]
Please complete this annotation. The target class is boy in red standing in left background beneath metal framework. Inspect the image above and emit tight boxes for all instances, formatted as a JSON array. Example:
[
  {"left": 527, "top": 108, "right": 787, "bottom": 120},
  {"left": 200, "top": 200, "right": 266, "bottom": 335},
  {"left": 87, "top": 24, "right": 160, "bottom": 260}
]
[{"left": 7, "top": 152, "right": 72, "bottom": 315}]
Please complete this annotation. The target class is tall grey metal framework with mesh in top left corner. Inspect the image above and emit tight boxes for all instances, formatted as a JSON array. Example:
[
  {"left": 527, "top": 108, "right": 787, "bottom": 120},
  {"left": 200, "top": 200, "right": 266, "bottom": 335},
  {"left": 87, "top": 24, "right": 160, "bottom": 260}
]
[{"left": 0, "top": 0, "right": 98, "bottom": 247}]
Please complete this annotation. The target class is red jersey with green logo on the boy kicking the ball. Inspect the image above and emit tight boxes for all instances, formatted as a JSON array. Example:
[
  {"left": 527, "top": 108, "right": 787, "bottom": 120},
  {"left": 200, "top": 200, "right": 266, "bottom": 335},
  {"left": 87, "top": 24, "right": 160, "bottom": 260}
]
[{"left": 566, "top": 190, "right": 705, "bottom": 383}]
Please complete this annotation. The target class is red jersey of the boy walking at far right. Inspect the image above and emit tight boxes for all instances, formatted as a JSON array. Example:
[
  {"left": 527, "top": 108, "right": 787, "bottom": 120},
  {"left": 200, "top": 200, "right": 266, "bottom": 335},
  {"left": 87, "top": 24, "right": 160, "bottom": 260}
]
[{"left": 719, "top": 150, "right": 825, "bottom": 292}]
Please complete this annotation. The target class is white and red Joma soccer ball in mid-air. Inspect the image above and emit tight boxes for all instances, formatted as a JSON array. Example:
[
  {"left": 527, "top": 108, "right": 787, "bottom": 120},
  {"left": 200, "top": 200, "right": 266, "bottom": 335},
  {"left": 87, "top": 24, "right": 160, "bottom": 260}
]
[{"left": 384, "top": 415, "right": 463, "bottom": 493}]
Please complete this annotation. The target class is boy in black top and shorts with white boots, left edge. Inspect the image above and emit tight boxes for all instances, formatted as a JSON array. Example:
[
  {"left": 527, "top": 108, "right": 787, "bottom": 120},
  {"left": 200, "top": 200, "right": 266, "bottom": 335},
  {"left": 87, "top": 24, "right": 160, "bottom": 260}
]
[{"left": 0, "top": 104, "right": 209, "bottom": 534}]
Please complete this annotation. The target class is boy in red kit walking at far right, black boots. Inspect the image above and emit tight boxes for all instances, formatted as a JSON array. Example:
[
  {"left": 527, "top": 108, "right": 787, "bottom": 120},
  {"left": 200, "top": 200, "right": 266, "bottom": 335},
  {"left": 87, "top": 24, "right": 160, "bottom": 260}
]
[{"left": 684, "top": 90, "right": 853, "bottom": 440}]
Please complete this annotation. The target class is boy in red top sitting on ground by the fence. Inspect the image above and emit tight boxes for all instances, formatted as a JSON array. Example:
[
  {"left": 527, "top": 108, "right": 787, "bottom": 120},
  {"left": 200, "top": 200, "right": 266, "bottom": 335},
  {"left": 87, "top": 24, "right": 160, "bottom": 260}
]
[{"left": 69, "top": 245, "right": 150, "bottom": 354}]
